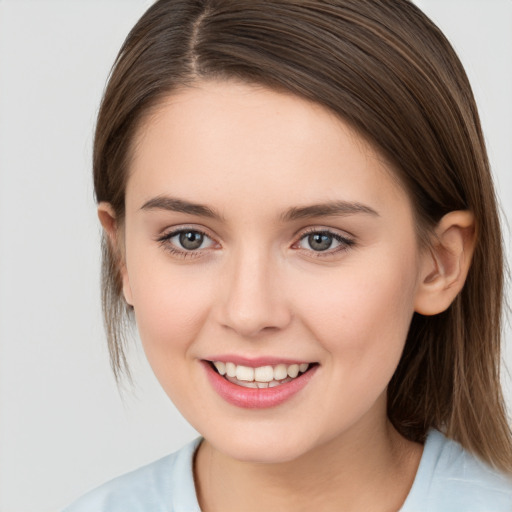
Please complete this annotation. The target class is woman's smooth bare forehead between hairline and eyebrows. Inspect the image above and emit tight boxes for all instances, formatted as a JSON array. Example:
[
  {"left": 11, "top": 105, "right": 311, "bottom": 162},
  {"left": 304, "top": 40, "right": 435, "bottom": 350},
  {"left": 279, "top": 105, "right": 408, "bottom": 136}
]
[{"left": 127, "top": 82, "right": 407, "bottom": 218}]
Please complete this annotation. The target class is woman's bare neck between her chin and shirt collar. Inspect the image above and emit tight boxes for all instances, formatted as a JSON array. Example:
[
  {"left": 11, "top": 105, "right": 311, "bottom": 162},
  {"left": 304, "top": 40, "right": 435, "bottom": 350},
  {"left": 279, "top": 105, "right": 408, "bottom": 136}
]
[{"left": 195, "top": 414, "right": 422, "bottom": 512}]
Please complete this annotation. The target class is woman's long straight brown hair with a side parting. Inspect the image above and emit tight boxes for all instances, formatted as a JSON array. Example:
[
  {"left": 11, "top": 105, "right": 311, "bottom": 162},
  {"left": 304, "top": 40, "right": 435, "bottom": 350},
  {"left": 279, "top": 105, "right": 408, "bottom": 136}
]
[{"left": 94, "top": 0, "right": 512, "bottom": 472}]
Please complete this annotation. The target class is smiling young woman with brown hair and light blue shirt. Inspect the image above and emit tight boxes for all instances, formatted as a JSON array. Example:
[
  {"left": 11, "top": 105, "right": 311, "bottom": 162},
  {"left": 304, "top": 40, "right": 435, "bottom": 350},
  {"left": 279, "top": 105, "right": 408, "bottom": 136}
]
[{"left": 64, "top": 0, "right": 512, "bottom": 512}]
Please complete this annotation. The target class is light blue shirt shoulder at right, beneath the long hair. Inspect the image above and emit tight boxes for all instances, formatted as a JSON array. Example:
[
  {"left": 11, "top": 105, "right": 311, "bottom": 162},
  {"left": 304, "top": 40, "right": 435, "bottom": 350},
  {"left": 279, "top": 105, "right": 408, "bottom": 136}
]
[{"left": 402, "top": 431, "right": 512, "bottom": 512}]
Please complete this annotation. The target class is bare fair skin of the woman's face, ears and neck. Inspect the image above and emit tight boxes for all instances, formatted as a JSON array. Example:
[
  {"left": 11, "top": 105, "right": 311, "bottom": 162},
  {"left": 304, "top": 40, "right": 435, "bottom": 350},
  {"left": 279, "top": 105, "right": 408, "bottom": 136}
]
[{"left": 99, "top": 82, "right": 474, "bottom": 512}]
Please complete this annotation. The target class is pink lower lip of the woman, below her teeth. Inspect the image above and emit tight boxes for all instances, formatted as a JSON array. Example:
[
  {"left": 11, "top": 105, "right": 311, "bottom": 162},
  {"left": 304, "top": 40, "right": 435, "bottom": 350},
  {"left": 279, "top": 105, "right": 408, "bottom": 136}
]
[{"left": 202, "top": 361, "right": 318, "bottom": 409}]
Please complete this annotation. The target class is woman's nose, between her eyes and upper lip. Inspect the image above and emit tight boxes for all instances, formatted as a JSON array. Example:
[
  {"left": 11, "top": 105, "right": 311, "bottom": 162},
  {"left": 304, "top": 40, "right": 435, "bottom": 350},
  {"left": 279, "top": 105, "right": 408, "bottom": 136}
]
[{"left": 219, "top": 247, "right": 292, "bottom": 338}]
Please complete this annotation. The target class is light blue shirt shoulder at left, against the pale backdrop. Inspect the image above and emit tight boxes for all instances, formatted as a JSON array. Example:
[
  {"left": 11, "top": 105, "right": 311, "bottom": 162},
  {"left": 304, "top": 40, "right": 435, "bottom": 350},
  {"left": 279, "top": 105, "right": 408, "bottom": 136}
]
[{"left": 63, "top": 438, "right": 201, "bottom": 512}]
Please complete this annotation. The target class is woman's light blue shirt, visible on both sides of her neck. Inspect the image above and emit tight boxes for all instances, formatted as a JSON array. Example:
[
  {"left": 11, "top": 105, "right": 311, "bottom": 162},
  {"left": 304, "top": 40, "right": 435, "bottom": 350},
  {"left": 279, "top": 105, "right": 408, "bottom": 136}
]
[{"left": 64, "top": 430, "right": 512, "bottom": 512}]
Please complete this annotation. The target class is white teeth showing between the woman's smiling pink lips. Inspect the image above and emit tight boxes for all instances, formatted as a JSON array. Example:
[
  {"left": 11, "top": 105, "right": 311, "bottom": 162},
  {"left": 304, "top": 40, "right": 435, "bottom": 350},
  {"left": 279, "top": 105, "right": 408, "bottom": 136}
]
[{"left": 209, "top": 361, "right": 318, "bottom": 389}]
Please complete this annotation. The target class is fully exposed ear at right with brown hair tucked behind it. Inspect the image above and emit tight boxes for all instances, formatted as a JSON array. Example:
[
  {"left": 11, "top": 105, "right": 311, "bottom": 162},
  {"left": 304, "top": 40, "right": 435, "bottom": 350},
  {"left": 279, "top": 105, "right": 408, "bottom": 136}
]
[{"left": 414, "top": 210, "right": 476, "bottom": 315}]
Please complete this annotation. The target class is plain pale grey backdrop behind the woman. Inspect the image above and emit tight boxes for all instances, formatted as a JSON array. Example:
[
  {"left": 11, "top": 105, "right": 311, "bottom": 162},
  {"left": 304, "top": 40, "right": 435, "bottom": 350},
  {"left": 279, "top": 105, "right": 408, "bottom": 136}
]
[{"left": 0, "top": 0, "right": 512, "bottom": 512}]
